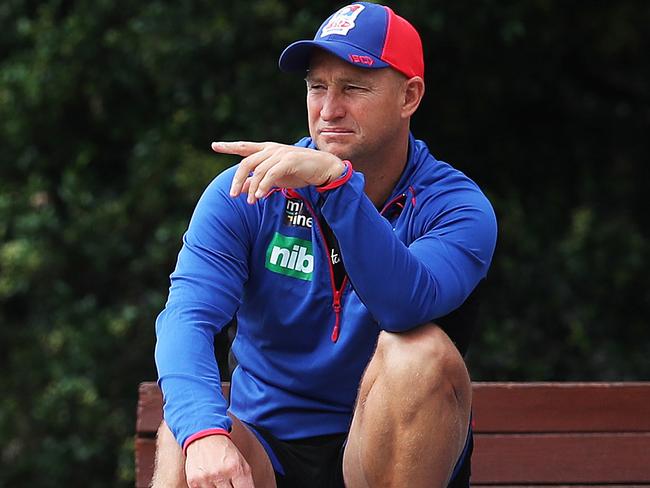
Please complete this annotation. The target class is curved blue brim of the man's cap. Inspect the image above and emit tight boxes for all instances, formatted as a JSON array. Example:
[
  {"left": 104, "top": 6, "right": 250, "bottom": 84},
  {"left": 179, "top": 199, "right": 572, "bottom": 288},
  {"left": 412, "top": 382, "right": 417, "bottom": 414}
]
[{"left": 278, "top": 41, "right": 390, "bottom": 71}]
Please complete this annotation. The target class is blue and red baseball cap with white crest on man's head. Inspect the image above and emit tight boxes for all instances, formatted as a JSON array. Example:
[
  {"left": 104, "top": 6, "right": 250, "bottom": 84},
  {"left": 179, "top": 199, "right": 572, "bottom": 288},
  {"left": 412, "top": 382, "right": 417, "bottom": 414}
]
[{"left": 279, "top": 2, "right": 424, "bottom": 78}]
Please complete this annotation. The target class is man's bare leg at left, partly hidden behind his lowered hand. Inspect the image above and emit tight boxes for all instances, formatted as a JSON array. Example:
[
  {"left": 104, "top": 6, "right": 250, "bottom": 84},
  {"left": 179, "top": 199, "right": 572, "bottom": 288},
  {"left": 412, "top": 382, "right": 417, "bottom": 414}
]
[{"left": 151, "top": 415, "right": 275, "bottom": 488}]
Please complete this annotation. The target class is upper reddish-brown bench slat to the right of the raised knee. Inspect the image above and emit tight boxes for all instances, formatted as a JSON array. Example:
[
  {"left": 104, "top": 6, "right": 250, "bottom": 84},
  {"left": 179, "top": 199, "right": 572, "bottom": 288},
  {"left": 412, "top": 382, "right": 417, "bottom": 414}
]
[{"left": 472, "top": 382, "right": 650, "bottom": 433}]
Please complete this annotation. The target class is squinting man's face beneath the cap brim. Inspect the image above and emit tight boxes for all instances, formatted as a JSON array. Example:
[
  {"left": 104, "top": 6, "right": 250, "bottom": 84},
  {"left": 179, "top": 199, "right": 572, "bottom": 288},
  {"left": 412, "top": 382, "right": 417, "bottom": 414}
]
[{"left": 306, "top": 50, "right": 406, "bottom": 164}]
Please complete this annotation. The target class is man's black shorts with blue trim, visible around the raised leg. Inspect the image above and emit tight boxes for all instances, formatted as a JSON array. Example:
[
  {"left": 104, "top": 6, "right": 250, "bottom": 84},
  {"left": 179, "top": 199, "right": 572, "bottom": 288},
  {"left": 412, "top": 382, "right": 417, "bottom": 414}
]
[{"left": 240, "top": 423, "right": 474, "bottom": 488}]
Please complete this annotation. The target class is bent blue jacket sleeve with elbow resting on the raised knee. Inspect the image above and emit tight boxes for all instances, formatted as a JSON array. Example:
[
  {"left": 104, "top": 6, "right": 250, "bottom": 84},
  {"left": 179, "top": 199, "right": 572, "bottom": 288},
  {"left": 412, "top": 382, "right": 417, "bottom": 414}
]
[{"left": 322, "top": 168, "right": 496, "bottom": 331}]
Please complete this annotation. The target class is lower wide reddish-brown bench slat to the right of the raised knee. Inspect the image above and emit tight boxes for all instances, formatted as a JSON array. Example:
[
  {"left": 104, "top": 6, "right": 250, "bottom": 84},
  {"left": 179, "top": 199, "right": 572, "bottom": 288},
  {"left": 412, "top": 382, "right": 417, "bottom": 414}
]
[{"left": 472, "top": 433, "right": 650, "bottom": 485}]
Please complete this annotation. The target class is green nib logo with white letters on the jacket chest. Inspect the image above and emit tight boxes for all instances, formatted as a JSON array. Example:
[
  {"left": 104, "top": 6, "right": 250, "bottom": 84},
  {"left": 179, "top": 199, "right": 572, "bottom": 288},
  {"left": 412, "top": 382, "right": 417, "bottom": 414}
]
[{"left": 266, "top": 232, "right": 314, "bottom": 281}]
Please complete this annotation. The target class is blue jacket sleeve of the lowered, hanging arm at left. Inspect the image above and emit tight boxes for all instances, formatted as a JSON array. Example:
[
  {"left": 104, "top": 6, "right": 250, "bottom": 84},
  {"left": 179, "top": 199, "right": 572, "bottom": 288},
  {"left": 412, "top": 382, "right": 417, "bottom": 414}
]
[{"left": 155, "top": 169, "right": 253, "bottom": 445}]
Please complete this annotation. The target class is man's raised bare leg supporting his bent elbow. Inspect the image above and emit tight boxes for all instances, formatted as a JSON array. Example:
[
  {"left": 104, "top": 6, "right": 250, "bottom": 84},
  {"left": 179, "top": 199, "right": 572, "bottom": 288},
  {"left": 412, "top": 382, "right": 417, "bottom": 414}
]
[{"left": 343, "top": 324, "right": 472, "bottom": 488}]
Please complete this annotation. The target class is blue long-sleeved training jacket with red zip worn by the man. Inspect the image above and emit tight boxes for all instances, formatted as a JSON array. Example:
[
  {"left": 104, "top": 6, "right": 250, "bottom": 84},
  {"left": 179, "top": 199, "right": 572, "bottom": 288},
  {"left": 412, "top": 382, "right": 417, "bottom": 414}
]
[{"left": 156, "top": 136, "right": 496, "bottom": 445}]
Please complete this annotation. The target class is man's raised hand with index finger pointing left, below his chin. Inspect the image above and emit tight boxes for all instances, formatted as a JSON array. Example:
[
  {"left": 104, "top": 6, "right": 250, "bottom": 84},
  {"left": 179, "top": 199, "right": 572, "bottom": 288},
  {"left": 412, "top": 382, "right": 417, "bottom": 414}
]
[{"left": 212, "top": 141, "right": 345, "bottom": 204}]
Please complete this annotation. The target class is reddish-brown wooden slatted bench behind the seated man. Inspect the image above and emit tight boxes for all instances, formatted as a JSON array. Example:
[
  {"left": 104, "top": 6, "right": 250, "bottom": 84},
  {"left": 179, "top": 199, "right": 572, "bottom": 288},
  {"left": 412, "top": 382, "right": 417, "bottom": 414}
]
[{"left": 135, "top": 382, "right": 650, "bottom": 487}]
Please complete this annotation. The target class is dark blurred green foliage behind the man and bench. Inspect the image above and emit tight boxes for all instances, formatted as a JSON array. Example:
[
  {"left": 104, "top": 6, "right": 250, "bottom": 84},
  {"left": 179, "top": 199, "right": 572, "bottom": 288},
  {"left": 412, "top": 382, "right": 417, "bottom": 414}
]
[{"left": 0, "top": 0, "right": 650, "bottom": 487}]
